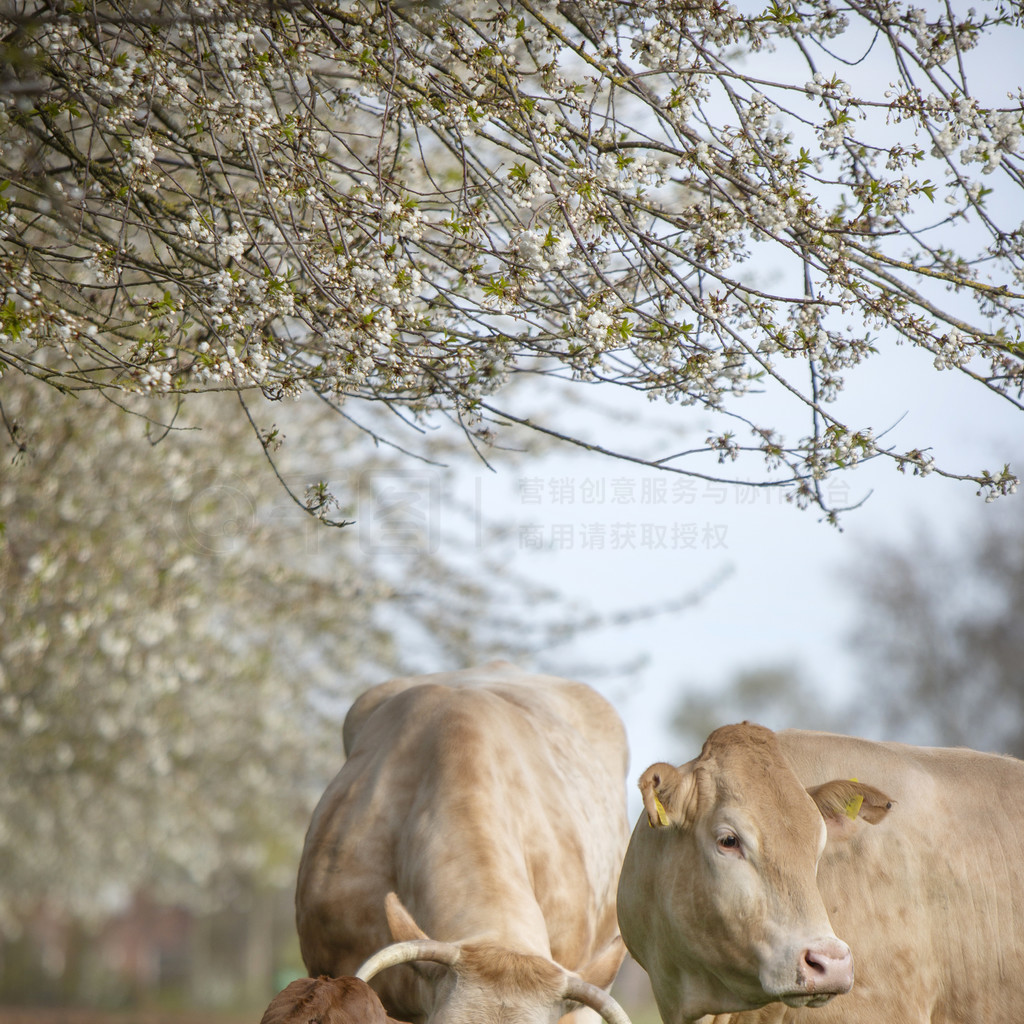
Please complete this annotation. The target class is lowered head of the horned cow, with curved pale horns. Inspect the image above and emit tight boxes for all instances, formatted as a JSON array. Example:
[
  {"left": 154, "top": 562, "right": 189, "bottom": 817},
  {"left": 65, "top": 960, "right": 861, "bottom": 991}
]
[{"left": 356, "top": 893, "right": 630, "bottom": 1024}]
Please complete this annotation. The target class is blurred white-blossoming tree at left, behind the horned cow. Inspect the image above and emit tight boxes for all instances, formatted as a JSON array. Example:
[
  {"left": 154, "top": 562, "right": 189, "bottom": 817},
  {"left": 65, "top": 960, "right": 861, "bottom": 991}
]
[{"left": 0, "top": 375, "right": 547, "bottom": 930}]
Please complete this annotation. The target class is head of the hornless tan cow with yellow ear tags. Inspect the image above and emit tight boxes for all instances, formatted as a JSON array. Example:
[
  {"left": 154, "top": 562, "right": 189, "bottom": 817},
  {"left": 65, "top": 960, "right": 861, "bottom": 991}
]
[{"left": 618, "top": 722, "right": 891, "bottom": 1024}]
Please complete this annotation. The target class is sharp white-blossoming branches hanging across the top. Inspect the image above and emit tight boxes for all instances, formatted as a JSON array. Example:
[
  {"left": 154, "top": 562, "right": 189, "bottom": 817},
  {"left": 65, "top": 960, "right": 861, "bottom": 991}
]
[{"left": 0, "top": 0, "right": 1024, "bottom": 512}]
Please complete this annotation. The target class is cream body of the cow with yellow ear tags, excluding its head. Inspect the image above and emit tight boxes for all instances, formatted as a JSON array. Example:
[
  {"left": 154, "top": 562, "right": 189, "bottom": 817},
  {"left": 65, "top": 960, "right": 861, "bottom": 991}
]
[{"left": 765, "top": 730, "right": 1024, "bottom": 1024}]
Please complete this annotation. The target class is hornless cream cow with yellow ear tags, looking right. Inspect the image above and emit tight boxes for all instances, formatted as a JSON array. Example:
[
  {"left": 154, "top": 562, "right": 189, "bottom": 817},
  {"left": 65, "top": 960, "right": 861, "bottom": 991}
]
[{"left": 618, "top": 723, "right": 1024, "bottom": 1024}]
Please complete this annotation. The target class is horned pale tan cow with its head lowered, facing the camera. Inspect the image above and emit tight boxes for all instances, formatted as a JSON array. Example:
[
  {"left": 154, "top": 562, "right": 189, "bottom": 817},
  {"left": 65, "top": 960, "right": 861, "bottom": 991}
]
[{"left": 295, "top": 662, "right": 629, "bottom": 1024}]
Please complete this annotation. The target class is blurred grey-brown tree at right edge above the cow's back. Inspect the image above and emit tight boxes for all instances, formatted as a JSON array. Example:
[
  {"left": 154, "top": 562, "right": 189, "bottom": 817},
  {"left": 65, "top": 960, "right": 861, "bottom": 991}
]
[{"left": 850, "top": 499, "right": 1024, "bottom": 757}]
